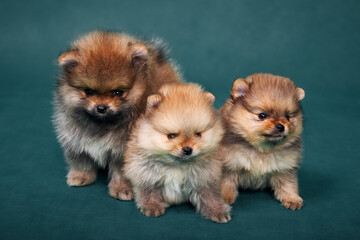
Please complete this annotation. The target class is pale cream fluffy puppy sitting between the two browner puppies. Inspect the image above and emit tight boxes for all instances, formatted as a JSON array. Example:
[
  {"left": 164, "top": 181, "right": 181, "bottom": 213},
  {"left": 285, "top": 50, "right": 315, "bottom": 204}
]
[{"left": 124, "top": 83, "right": 230, "bottom": 223}]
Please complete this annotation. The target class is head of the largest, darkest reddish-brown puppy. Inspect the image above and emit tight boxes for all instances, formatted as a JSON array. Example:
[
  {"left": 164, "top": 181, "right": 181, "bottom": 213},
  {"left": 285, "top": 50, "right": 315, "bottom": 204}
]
[{"left": 58, "top": 33, "right": 148, "bottom": 122}]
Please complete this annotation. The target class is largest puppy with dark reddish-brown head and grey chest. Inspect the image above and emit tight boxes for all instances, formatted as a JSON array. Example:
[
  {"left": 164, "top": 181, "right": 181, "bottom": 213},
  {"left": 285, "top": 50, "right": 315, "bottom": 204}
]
[{"left": 53, "top": 32, "right": 179, "bottom": 200}]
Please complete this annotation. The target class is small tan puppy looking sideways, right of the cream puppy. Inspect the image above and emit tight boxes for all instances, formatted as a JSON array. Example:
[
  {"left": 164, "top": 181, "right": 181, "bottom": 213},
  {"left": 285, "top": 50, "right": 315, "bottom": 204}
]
[{"left": 218, "top": 74, "right": 305, "bottom": 210}]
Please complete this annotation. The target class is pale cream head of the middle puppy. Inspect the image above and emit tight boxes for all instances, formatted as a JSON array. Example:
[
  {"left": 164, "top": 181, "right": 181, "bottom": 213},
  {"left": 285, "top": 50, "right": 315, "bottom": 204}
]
[{"left": 139, "top": 84, "right": 223, "bottom": 163}]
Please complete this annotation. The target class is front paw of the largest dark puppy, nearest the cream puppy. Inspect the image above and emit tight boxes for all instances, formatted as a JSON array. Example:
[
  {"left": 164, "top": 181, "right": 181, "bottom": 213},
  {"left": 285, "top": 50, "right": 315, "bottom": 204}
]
[{"left": 109, "top": 180, "right": 134, "bottom": 201}]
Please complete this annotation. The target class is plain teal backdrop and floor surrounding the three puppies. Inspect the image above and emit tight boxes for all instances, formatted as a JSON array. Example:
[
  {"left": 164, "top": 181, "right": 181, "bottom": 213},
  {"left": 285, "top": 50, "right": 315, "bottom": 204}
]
[{"left": 0, "top": 0, "right": 360, "bottom": 240}]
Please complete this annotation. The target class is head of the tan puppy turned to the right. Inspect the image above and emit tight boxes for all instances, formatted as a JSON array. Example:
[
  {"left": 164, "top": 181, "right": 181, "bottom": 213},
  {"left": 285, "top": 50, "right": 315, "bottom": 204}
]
[{"left": 228, "top": 74, "right": 305, "bottom": 149}]
